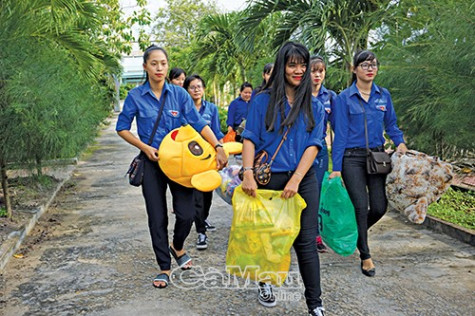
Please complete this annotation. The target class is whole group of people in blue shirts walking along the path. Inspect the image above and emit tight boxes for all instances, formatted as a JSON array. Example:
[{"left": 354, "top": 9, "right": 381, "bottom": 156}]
[{"left": 116, "top": 42, "right": 407, "bottom": 316}]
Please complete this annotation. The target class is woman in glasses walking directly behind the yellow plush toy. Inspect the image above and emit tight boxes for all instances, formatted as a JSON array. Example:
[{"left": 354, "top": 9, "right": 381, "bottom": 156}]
[{"left": 183, "top": 75, "right": 224, "bottom": 250}]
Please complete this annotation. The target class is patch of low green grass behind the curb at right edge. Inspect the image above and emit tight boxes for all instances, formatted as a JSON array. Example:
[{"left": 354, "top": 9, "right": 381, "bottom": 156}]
[{"left": 427, "top": 188, "right": 475, "bottom": 229}]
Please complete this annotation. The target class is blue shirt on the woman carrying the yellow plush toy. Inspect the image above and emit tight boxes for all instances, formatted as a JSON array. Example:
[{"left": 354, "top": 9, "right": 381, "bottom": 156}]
[{"left": 115, "top": 82, "right": 206, "bottom": 148}]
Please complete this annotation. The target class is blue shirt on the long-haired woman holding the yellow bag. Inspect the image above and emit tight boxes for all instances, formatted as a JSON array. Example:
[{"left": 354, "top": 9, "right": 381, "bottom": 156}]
[{"left": 242, "top": 93, "right": 324, "bottom": 172}]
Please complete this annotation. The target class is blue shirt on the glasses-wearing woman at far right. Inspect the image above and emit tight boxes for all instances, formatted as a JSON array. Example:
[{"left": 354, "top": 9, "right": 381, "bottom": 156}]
[{"left": 332, "top": 82, "right": 404, "bottom": 171}]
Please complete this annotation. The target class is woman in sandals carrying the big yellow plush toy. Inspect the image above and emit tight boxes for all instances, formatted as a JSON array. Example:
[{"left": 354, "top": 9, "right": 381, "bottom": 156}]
[{"left": 116, "top": 45, "right": 227, "bottom": 288}]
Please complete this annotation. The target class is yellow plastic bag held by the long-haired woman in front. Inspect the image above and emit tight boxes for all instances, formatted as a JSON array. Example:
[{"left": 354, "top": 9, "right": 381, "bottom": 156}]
[{"left": 226, "top": 186, "right": 307, "bottom": 286}]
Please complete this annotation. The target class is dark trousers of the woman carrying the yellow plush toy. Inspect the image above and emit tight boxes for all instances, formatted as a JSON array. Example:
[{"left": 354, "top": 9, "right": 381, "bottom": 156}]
[{"left": 142, "top": 159, "right": 195, "bottom": 270}]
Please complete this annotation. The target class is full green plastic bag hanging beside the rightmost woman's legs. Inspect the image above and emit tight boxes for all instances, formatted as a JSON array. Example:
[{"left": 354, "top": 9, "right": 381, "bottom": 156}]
[{"left": 318, "top": 172, "right": 358, "bottom": 257}]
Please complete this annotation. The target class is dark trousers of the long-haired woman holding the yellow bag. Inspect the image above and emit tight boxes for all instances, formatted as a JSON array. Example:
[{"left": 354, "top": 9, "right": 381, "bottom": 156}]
[{"left": 259, "top": 168, "right": 322, "bottom": 310}]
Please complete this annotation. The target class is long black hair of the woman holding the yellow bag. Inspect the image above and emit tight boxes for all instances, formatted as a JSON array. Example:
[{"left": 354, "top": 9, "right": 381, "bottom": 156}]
[{"left": 264, "top": 42, "right": 315, "bottom": 133}]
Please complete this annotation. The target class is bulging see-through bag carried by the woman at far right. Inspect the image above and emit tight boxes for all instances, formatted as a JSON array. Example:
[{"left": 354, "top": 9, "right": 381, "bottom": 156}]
[{"left": 386, "top": 150, "right": 454, "bottom": 224}]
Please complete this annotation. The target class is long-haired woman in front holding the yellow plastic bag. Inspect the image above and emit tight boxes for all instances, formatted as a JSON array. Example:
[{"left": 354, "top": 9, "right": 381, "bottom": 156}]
[{"left": 242, "top": 42, "right": 324, "bottom": 315}]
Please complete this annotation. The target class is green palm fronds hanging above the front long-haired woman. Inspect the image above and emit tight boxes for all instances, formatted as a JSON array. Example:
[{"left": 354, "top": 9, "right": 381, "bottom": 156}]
[{"left": 241, "top": 0, "right": 390, "bottom": 84}]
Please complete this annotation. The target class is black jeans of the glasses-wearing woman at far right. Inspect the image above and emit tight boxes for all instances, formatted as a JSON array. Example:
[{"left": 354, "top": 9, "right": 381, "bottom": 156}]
[{"left": 341, "top": 148, "right": 388, "bottom": 260}]
